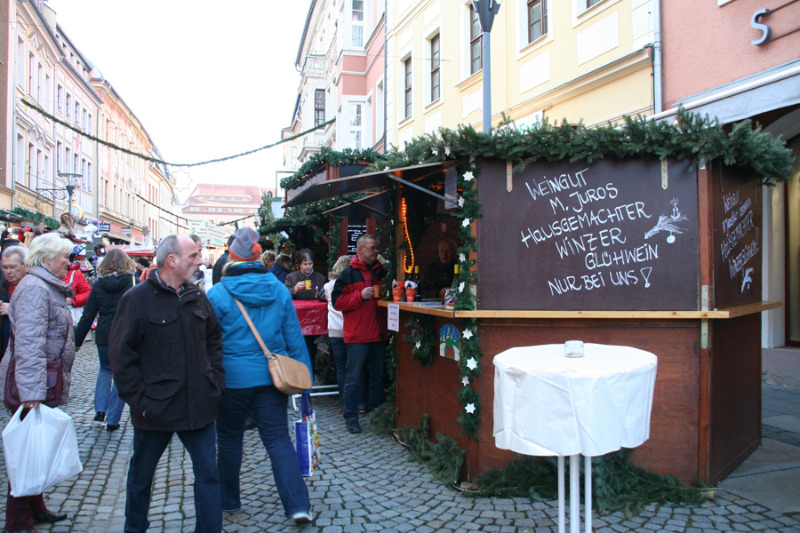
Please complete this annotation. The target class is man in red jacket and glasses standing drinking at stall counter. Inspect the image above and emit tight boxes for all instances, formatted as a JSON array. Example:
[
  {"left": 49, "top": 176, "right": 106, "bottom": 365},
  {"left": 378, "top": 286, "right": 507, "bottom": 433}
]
[{"left": 331, "top": 233, "right": 386, "bottom": 433}]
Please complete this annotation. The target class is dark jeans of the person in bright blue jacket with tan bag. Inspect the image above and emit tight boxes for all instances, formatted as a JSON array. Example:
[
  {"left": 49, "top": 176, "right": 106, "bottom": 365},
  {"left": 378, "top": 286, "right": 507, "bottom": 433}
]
[{"left": 217, "top": 385, "right": 311, "bottom": 516}]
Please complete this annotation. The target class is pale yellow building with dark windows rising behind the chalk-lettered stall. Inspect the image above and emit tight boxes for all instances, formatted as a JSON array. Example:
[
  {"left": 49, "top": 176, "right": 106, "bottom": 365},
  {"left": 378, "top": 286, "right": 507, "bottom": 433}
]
[{"left": 387, "top": 0, "right": 658, "bottom": 148}]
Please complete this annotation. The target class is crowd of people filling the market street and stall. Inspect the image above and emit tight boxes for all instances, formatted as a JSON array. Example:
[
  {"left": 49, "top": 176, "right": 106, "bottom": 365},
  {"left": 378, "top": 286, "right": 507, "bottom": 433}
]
[{"left": 0, "top": 224, "right": 455, "bottom": 532}]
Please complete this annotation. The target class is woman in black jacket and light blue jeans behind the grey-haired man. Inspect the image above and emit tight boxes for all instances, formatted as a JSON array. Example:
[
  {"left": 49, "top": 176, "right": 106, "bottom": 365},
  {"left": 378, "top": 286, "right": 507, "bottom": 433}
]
[{"left": 75, "top": 248, "right": 135, "bottom": 432}]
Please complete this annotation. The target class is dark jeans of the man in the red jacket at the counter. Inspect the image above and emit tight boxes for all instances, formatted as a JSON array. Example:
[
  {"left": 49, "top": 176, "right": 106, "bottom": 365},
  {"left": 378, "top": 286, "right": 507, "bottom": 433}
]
[{"left": 344, "top": 342, "right": 386, "bottom": 420}]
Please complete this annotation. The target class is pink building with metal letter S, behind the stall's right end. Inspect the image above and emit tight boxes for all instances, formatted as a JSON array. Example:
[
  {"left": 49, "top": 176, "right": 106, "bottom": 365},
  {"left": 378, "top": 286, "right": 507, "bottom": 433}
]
[{"left": 661, "top": 0, "right": 800, "bottom": 387}]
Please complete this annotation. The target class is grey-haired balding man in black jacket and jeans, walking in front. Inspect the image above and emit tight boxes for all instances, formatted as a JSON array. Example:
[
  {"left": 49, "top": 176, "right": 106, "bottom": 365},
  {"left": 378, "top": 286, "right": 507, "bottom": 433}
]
[{"left": 109, "top": 235, "right": 225, "bottom": 532}]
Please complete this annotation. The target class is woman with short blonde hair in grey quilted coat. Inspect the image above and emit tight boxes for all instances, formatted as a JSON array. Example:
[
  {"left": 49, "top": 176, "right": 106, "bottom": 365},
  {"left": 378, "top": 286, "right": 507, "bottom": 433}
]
[{"left": 0, "top": 232, "right": 75, "bottom": 531}]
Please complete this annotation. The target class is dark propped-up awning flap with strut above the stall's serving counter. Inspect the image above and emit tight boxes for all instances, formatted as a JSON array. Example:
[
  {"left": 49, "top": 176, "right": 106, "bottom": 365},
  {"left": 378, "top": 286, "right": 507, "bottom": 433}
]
[{"left": 284, "top": 161, "right": 461, "bottom": 207}]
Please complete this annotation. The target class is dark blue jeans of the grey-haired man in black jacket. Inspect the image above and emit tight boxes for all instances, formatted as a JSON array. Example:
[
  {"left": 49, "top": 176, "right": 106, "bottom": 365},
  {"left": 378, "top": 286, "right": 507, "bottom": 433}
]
[{"left": 125, "top": 424, "right": 222, "bottom": 533}]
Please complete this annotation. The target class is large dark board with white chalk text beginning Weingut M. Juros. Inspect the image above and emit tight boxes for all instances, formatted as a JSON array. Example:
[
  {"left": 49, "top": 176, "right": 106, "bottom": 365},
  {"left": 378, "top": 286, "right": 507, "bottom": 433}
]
[{"left": 478, "top": 159, "right": 698, "bottom": 310}]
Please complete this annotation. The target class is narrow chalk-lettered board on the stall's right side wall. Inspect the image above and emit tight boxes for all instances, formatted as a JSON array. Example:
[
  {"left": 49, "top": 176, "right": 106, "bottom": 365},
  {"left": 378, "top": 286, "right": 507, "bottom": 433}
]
[{"left": 712, "top": 167, "right": 763, "bottom": 308}]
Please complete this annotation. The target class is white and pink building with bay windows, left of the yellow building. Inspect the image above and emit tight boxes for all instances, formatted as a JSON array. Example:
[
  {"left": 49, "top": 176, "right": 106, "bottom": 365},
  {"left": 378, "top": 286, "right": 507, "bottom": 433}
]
[{"left": 283, "top": 0, "right": 386, "bottom": 170}]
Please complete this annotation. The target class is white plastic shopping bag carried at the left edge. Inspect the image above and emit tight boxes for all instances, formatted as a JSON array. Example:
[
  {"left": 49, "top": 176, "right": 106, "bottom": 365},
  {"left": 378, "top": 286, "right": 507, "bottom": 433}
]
[{"left": 3, "top": 404, "right": 83, "bottom": 498}]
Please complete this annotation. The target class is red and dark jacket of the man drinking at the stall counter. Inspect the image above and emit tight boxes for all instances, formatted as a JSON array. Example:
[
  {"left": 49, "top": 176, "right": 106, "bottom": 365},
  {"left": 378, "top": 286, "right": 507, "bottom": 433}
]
[{"left": 331, "top": 257, "right": 386, "bottom": 344}]
